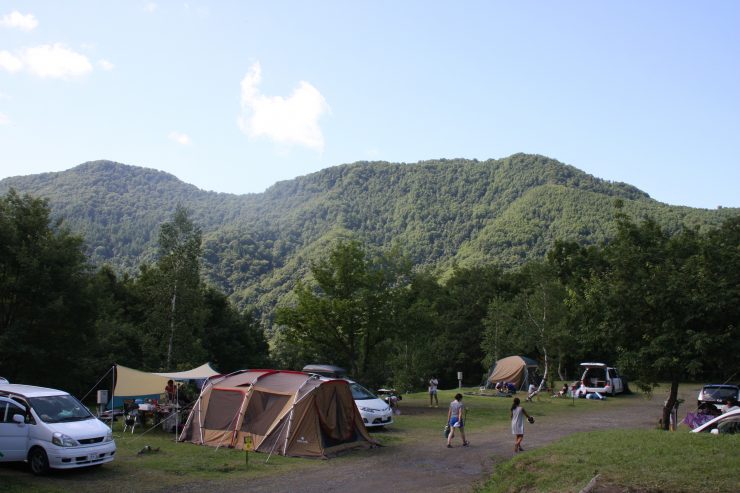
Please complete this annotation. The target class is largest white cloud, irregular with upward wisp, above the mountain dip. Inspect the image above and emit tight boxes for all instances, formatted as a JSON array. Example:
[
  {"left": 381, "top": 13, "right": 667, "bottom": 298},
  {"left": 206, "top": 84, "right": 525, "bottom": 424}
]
[{"left": 237, "top": 62, "right": 329, "bottom": 151}]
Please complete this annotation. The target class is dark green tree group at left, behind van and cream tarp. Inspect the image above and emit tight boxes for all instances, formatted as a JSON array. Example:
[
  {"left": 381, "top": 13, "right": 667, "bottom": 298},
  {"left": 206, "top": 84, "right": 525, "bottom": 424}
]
[{"left": 0, "top": 190, "right": 269, "bottom": 388}]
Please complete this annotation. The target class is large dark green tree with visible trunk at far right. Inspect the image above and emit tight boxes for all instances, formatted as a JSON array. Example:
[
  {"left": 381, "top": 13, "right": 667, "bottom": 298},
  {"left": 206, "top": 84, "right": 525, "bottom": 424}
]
[{"left": 582, "top": 215, "right": 736, "bottom": 429}]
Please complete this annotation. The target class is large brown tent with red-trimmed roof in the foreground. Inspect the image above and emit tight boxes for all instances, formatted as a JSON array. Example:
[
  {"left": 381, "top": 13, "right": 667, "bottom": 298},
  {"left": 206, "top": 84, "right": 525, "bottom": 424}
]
[{"left": 179, "top": 370, "right": 376, "bottom": 457}]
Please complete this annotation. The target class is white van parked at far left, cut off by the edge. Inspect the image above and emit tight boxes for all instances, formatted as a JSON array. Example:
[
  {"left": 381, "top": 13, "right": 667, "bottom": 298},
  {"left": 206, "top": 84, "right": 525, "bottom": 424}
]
[{"left": 0, "top": 384, "right": 116, "bottom": 475}]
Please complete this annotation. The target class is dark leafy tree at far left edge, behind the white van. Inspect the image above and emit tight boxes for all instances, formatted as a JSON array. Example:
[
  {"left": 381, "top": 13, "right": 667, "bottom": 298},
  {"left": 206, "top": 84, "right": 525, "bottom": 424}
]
[{"left": 0, "top": 190, "right": 94, "bottom": 392}]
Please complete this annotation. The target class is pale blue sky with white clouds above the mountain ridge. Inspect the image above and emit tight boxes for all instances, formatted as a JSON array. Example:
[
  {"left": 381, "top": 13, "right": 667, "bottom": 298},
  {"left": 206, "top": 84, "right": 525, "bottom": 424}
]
[{"left": 0, "top": 0, "right": 740, "bottom": 208}]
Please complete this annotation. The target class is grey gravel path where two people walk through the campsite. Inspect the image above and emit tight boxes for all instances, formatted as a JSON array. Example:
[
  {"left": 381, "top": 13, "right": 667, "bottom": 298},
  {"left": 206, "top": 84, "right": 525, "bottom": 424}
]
[{"left": 165, "top": 395, "right": 662, "bottom": 493}]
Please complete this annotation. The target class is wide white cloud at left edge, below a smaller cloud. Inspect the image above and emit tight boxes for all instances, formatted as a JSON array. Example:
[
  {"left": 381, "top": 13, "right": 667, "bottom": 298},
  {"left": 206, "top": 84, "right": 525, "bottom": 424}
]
[{"left": 0, "top": 43, "right": 93, "bottom": 79}]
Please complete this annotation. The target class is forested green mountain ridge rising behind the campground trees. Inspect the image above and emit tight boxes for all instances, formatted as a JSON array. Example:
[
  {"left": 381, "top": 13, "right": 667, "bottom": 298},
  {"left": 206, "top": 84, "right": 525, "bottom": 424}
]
[{"left": 0, "top": 154, "right": 740, "bottom": 316}]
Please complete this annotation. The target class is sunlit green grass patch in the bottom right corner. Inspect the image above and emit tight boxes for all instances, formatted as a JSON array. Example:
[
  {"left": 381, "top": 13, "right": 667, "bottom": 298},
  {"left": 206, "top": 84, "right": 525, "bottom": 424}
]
[{"left": 477, "top": 430, "right": 740, "bottom": 493}]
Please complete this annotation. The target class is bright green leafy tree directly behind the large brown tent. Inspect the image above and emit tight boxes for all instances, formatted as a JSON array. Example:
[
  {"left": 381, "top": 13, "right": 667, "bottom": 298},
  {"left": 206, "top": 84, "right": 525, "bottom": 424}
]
[{"left": 276, "top": 241, "right": 408, "bottom": 383}]
